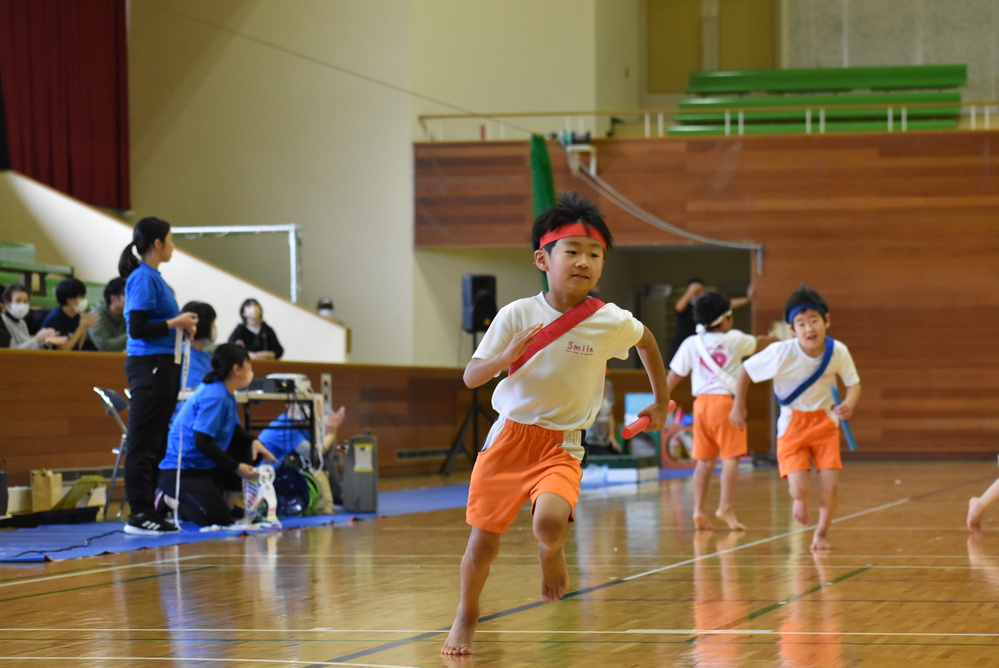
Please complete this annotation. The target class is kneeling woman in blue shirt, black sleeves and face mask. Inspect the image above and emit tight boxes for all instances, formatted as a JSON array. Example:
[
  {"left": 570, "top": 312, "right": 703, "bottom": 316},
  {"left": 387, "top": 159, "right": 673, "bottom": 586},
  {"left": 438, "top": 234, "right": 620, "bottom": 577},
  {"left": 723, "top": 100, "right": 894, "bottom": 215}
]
[{"left": 156, "top": 343, "right": 277, "bottom": 526}]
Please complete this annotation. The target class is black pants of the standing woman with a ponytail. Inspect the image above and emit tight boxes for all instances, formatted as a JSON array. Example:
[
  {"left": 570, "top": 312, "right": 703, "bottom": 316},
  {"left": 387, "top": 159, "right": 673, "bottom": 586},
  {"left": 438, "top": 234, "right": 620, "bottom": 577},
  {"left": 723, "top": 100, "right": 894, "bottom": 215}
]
[{"left": 125, "top": 355, "right": 180, "bottom": 515}]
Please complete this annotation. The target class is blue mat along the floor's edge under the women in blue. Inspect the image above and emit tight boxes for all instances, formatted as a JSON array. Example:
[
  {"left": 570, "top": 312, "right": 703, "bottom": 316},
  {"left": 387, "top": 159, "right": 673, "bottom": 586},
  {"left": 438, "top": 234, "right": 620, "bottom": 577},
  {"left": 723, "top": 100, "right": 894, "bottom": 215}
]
[{"left": 0, "top": 469, "right": 693, "bottom": 563}]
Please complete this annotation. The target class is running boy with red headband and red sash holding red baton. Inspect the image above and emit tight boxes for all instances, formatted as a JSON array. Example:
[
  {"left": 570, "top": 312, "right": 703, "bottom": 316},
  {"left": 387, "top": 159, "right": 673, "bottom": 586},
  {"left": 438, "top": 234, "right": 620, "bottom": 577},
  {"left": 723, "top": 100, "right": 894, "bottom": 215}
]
[{"left": 441, "top": 193, "right": 672, "bottom": 654}]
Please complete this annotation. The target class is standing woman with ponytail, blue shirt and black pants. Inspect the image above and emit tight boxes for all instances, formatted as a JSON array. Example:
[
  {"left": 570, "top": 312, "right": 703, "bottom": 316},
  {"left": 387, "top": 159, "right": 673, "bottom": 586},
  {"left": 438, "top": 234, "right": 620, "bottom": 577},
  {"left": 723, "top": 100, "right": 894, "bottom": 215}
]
[{"left": 118, "top": 218, "right": 198, "bottom": 535}]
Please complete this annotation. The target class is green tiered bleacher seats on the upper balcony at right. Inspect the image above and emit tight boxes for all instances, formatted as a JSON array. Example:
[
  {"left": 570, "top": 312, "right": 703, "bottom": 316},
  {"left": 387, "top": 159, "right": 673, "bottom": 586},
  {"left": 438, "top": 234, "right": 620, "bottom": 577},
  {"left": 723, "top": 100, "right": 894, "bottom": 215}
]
[{"left": 669, "top": 65, "right": 967, "bottom": 135}]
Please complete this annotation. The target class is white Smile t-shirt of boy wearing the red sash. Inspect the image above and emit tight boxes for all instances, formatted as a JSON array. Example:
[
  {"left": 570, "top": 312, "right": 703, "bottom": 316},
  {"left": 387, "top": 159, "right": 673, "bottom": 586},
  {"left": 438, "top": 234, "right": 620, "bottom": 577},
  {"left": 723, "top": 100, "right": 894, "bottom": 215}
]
[{"left": 473, "top": 293, "right": 645, "bottom": 431}]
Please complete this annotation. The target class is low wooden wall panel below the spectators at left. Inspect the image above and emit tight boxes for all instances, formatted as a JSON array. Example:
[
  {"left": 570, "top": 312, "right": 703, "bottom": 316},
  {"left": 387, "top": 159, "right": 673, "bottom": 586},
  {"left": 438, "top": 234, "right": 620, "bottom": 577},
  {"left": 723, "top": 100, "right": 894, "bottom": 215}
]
[{"left": 0, "top": 350, "right": 480, "bottom": 484}]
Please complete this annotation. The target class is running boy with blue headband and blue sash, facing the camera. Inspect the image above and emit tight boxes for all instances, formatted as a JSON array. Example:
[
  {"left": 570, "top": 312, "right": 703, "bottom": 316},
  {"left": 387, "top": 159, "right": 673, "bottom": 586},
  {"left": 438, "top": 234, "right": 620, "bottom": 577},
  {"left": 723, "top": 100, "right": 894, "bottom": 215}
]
[{"left": 730, "top": 285, "right": 860, "bottom": 552}]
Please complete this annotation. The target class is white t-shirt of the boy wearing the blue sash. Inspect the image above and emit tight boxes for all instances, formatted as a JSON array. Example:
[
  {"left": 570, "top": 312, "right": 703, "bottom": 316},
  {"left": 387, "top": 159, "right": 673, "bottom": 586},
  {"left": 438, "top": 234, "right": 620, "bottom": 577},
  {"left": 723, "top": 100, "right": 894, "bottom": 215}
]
[{"left": 743, "top": 339, "right": 860, "bottom": 436}]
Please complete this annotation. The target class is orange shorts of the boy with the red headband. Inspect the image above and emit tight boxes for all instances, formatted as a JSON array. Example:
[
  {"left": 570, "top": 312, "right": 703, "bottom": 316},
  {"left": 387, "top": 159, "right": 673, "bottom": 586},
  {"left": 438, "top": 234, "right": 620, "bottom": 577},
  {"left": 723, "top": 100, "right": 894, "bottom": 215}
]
[{"left": 465, "top": 420, "right": 583, "bottom": 533}]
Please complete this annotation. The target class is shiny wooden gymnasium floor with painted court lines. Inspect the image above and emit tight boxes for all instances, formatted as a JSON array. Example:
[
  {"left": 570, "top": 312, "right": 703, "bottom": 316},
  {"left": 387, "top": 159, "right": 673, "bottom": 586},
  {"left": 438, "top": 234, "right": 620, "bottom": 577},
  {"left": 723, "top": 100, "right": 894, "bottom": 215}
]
[{"left": 0, "top": 462, "right": 999, "bottom": 668}]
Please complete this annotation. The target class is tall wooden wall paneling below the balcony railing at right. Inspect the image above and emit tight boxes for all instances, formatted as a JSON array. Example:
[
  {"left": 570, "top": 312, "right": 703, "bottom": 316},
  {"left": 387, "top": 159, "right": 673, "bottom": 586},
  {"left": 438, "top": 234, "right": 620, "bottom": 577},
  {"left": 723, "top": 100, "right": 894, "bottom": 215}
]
[{"left": 416, "top": 131, "right": 999, "bottom": 456}]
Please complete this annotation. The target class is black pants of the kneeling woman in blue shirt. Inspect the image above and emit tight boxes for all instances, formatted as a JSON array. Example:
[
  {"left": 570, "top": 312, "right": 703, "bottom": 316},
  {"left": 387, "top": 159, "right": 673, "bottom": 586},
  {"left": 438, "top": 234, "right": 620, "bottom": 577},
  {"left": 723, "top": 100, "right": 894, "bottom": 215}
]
[{"left": 159, "top": 438, "right": 251, "bottom": 527}]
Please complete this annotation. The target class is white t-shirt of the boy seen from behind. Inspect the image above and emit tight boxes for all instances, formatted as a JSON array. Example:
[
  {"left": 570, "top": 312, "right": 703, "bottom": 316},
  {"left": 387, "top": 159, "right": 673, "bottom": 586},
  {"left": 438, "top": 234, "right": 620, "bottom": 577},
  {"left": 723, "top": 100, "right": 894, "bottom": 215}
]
[{"left": 669, "top": 329, "right": 756, "bottom": 397}]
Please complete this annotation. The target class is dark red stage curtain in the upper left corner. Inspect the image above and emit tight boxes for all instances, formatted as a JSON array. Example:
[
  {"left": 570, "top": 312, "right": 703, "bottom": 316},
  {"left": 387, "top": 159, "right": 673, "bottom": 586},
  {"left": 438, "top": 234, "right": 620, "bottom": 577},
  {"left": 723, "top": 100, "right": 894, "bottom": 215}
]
[{"left": 0, "top": 0, "right": 130, "bottom": 209}]
